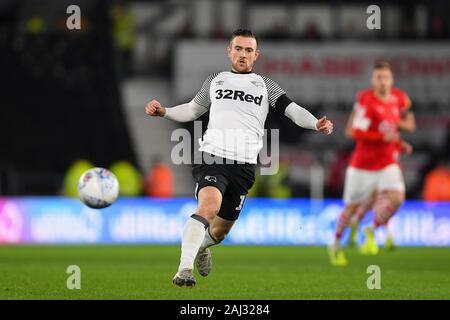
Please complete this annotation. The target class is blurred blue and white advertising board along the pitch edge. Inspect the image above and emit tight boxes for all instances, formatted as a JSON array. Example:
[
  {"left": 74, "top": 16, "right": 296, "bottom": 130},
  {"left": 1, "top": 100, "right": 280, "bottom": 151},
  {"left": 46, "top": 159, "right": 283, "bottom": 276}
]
[{"left": 0, "top": 197, "right": 450, "bottom": 246}]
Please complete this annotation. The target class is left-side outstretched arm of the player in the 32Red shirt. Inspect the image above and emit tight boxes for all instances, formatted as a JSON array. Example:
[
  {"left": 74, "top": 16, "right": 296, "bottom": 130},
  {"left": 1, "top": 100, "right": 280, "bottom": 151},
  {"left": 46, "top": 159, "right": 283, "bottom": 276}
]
[{"left": 145, "top": 100, "right": 208, "bottom": 122}]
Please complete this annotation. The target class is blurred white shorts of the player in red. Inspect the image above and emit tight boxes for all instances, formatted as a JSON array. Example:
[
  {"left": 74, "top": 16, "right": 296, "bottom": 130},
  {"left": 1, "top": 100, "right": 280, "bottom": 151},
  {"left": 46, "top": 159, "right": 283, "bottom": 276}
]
[{"left": 344, "top": 163, "right": 405, "bottom": 204}]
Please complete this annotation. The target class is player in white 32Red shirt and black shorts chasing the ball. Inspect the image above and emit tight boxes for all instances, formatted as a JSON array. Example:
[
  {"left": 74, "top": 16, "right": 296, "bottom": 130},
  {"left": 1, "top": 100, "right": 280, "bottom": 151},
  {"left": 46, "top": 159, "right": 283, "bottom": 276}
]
[{"left": 146, "top": 29, "right": 333, "bottom": 287}]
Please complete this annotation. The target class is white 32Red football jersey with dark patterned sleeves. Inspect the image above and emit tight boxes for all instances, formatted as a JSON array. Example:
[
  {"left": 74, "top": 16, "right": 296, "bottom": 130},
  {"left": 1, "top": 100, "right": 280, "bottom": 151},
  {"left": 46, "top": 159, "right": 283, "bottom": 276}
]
[{"left": 194, "top": 71, "right": 286, "bottom": 163}]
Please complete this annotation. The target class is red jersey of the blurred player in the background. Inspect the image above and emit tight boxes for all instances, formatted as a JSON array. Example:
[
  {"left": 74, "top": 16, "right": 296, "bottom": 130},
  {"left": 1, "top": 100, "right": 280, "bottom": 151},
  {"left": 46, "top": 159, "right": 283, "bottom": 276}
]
[{"left": 350, "top": 88, "right": 411, "bottom": 170}]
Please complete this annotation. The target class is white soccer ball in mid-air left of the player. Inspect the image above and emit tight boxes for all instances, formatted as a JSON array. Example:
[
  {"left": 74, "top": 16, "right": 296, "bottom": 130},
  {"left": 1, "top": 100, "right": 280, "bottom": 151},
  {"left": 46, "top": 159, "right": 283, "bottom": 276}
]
[{"left": 78, "top": 168, "right": 119, "bottom": 209}]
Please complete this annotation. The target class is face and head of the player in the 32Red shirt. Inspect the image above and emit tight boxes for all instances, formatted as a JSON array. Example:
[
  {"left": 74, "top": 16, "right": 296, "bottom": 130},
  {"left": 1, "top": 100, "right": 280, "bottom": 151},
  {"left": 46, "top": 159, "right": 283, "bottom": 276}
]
[{"left": 227, "top": 37, "right": 259, "bottom": 72}]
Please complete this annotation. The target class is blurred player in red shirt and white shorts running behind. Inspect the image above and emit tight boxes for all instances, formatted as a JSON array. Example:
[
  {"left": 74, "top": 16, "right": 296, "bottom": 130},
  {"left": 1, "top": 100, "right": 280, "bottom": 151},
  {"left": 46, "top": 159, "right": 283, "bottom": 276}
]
[{"left": 329, "top": 60, "right": 415, "bottom": 266}]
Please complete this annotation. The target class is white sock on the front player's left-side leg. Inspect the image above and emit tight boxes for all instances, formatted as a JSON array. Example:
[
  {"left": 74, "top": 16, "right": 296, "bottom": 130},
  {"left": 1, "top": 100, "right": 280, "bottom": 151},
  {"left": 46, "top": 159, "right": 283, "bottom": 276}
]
[{"left": 178, "top": 214, "right": 209, "bottom": 271}]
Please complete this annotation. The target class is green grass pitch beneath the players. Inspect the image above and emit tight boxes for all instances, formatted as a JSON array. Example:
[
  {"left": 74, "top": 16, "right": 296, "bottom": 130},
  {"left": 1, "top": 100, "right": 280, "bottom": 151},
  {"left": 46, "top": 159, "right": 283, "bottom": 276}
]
[{"left": 0, "top": 245, "right": 450, "bottom": 300}]
